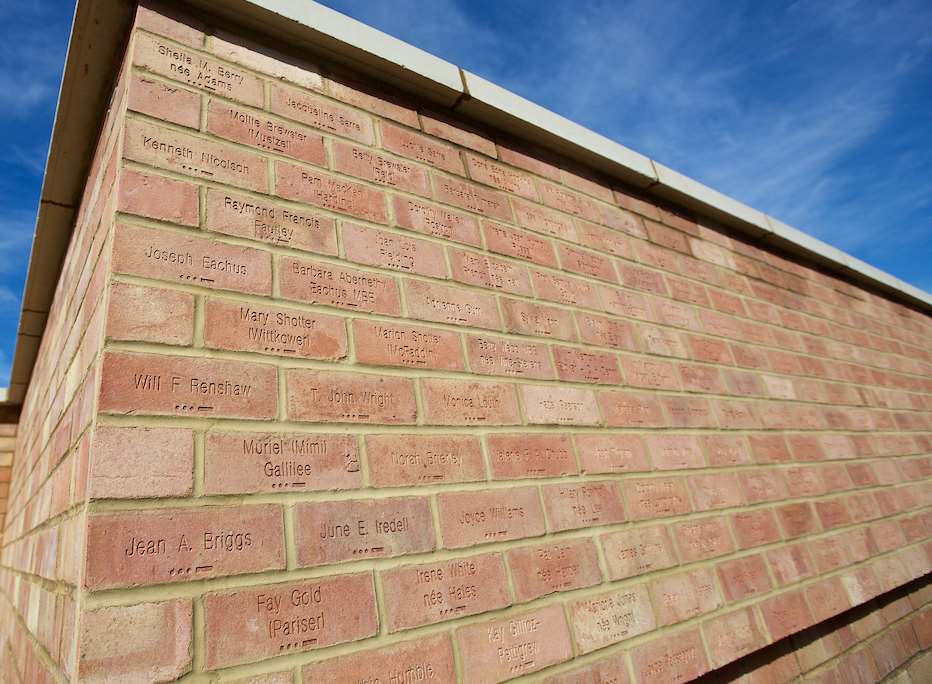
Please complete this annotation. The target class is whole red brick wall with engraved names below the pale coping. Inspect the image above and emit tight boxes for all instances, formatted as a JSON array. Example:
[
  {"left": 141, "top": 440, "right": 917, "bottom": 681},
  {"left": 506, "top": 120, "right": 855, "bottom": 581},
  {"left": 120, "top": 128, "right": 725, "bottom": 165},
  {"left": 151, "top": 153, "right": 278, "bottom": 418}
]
[{"left": 0, "top": 2, "right": 932, "bottom": 684}]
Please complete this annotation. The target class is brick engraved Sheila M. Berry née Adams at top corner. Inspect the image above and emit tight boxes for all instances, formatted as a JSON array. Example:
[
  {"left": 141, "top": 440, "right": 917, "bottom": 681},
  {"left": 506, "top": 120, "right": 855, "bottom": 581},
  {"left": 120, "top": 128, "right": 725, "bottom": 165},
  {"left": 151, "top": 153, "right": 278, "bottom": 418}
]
[{"left": 133, "top": 33, "right": 263, "bottom": 107}]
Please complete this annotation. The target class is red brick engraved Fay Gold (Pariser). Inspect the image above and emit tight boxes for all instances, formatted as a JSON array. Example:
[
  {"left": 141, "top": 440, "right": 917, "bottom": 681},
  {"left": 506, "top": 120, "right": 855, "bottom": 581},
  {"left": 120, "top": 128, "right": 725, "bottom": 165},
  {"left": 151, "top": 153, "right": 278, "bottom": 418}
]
[{"left": 204, "top": 573, "right": 379, "bottom": 670}]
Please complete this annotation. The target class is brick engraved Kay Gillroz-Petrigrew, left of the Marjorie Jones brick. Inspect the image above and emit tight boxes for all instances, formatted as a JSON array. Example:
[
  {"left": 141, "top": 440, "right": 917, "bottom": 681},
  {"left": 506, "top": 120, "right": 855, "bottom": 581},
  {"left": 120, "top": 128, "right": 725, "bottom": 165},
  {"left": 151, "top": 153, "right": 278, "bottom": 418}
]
[{"left": 456, "top": 606, "right": 573, "bottom": 684}]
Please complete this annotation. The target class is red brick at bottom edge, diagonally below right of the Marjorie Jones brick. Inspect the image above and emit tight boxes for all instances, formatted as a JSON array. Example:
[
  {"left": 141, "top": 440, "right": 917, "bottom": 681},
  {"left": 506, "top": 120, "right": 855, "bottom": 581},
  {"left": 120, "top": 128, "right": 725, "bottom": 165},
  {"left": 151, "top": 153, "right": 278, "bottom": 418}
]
[{"left": 631, "top": 628, "right": 709, "bottom": 684}]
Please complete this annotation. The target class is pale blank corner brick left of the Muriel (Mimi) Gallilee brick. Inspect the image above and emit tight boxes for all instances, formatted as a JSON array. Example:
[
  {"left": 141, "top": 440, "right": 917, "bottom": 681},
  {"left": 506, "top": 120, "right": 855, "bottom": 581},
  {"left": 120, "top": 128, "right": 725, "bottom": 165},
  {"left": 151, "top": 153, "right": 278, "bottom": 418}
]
[{"left": 90, "top": 425, "right": 194, "bottom": 499}]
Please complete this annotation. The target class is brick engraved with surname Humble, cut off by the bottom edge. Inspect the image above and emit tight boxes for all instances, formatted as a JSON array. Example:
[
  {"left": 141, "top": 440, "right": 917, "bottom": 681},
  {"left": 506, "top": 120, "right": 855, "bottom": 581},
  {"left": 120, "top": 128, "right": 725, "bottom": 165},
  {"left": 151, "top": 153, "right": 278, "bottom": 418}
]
[{"left": 302, "top": 634, "right": 456, "bottom": 684}]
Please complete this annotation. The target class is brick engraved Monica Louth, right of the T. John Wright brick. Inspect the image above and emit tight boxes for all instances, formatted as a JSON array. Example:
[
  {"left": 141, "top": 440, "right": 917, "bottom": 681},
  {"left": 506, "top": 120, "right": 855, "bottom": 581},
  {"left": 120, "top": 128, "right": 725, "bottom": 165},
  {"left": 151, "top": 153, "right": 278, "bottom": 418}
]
[{"left": 421, "top": 378, "right": 521, "bottom": 425}]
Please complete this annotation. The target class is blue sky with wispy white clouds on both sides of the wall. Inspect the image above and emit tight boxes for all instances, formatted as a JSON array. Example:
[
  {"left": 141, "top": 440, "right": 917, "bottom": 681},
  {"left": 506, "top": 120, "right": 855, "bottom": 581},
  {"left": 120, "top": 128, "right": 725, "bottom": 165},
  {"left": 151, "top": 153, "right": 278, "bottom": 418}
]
[{"left": 0, "top": 0, "right": 932, "bottom": 387}]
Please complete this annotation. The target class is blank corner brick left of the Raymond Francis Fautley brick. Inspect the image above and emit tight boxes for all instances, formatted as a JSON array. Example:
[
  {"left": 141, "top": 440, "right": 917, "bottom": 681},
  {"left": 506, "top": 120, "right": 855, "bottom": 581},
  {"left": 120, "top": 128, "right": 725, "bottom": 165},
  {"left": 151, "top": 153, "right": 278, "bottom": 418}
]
[{"left": 117, "top": 169, "right": 200, "bottom": 226}]
